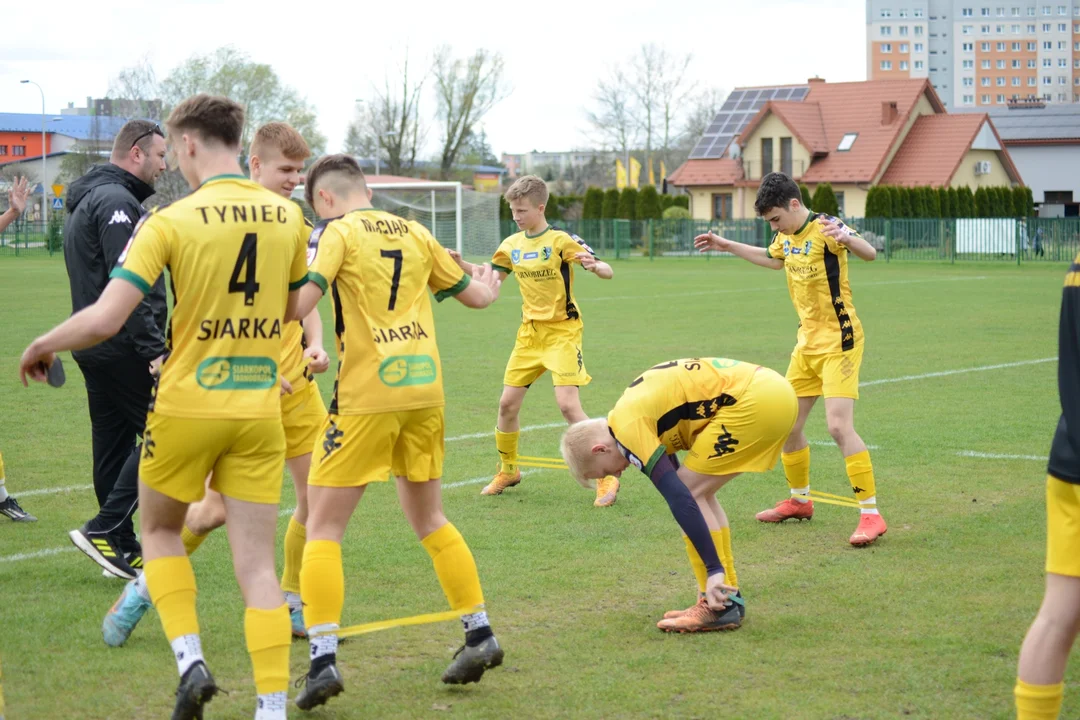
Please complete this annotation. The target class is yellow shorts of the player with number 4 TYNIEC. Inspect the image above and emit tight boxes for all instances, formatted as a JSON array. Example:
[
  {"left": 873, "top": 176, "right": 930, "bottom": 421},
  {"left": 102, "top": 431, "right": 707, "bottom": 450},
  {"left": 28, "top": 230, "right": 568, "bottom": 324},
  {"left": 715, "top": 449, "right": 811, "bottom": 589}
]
[{"left": 138, "top": 412, "right": 285, "bottom": 504}]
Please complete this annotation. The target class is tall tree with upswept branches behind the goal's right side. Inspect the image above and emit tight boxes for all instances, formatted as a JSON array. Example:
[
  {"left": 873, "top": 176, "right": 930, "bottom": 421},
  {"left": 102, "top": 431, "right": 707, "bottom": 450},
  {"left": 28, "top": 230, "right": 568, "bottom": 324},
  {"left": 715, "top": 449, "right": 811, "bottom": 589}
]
[{"left": 432, "top": 45, "right": 509, "bottom": 179}]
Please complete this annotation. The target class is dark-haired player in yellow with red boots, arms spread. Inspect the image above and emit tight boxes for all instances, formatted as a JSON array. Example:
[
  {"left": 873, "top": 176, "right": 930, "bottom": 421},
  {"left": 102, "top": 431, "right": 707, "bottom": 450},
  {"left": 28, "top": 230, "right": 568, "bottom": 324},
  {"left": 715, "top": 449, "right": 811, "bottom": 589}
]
[{"left": 694, "top": 173, "right": 887, "bottom": 546}]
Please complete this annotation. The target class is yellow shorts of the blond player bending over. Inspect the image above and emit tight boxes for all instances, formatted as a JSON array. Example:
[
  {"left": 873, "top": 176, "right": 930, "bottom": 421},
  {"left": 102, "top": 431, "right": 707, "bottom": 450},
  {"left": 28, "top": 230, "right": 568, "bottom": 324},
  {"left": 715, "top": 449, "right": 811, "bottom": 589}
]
[{"left": 684, "top": 367, "right": 799, "bottom": 475}]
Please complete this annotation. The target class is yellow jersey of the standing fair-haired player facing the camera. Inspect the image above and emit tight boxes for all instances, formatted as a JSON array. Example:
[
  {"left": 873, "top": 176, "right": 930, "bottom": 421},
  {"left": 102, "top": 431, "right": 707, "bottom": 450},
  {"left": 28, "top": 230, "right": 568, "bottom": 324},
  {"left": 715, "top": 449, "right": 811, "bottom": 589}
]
[{"left": 491, "top": 227, "right": 595, "bottom": 322}]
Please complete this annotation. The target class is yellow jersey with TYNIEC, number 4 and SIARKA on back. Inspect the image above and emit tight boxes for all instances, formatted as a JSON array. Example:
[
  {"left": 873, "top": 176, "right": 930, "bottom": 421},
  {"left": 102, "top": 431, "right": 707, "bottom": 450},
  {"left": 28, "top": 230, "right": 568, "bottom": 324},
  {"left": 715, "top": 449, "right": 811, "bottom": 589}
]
[{"left": 111, "top": 175, "right": 308, "bottom": 420}]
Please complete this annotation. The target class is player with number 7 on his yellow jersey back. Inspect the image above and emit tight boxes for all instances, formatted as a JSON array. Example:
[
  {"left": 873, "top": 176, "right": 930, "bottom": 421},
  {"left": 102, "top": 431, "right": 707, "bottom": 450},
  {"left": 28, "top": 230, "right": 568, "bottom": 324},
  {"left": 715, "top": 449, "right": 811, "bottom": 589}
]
[{"left": 287, "top": 155, "right": 503, "bottom": 710}]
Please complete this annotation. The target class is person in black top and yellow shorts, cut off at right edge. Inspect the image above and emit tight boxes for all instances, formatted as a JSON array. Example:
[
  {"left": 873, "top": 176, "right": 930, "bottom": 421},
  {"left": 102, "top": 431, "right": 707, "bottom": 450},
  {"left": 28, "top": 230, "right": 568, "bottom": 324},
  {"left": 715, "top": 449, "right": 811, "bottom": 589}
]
[{"left": 1014, "top": 255, "right": 1080, "bottom": 720}]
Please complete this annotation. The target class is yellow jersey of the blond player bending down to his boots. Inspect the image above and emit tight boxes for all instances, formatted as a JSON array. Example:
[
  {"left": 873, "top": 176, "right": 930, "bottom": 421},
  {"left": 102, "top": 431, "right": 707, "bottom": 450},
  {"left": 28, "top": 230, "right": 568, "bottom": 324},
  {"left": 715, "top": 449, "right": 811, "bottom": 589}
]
[{"left": 607, "top": 357, "right": 760, "bottom": 475}]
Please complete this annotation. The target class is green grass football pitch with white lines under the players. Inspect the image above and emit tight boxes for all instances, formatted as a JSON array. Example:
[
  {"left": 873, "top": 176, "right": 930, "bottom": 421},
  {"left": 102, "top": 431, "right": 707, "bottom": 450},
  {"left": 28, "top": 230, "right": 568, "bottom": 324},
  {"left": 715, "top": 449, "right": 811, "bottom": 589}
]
[{"left": 0, "top": 256, "right": 1067, "bottom": 720}]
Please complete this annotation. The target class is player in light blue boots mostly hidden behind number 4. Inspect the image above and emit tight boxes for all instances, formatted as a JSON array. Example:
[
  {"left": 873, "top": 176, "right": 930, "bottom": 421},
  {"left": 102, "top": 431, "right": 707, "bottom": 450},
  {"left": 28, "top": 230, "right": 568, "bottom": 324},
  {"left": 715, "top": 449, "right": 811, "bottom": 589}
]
[{"left": 100, "top": 122, "right": 329, "bottom": 648}]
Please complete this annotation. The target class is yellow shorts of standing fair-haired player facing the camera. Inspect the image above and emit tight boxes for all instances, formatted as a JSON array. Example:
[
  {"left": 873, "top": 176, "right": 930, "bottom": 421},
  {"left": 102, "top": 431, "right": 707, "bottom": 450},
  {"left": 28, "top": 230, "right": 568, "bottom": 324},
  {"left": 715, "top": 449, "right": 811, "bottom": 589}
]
[{"left": 502, "top": 320, "right": 592, "bottom": 388}]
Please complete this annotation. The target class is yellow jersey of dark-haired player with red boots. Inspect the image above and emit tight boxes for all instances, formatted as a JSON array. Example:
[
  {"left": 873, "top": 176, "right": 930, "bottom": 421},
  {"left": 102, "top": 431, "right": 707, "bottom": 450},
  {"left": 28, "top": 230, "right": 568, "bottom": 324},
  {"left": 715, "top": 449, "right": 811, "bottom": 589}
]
[{"left": 766, "top": 213, "right": 863, "bottom": 355}]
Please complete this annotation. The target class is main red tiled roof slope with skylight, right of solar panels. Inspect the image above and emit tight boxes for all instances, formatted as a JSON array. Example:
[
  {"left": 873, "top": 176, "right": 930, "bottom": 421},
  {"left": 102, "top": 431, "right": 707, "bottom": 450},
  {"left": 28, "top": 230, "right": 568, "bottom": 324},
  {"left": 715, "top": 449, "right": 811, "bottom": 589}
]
[{"left": 800, "top": 79, "right": 945, "bottom": 185}]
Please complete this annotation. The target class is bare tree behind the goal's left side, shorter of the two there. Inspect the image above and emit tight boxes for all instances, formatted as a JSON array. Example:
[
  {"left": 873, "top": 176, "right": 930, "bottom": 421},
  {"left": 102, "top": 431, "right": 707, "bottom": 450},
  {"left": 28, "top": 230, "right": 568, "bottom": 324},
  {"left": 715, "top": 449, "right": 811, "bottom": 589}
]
[{"left": 346, "top": 51, "right": 428, "bottom": 175}]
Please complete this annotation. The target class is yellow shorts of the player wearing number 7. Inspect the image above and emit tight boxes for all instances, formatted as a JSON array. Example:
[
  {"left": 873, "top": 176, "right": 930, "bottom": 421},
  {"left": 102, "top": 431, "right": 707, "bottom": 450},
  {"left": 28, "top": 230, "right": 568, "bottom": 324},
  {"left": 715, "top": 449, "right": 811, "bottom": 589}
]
[{"left": 308, "top": 407, "right": 445, "bottom": 488}]
